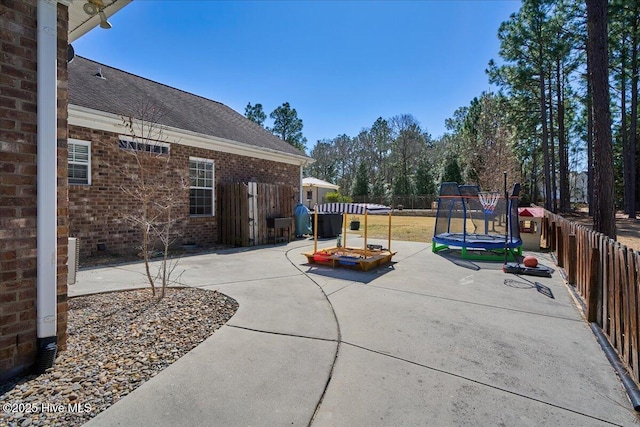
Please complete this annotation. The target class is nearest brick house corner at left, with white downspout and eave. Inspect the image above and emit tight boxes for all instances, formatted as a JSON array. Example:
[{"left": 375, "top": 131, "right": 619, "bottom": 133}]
[{"left": 0, "top": 0, "right": 130, "bottom": 381}]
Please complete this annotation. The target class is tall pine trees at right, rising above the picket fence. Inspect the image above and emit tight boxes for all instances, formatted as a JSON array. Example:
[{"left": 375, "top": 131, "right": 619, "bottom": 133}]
[{"left": 487, "top": 0, "right": 640, "bottom": 237}]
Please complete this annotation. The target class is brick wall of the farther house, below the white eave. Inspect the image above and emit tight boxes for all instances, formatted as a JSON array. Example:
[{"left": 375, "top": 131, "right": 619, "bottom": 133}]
[{"left": 69, "top": 126, "right": 300, "bottom": 257}]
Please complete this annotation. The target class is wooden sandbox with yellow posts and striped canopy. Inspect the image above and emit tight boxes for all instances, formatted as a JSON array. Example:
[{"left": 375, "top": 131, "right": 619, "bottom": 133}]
[{"left": 304, "top": 203, "right": 396, "bottom": 271}]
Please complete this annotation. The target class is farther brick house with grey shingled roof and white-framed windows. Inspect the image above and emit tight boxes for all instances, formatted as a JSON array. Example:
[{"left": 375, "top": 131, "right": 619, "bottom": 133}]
[{"left": 68, "top": 57, "right": 311, "bottom": 257}]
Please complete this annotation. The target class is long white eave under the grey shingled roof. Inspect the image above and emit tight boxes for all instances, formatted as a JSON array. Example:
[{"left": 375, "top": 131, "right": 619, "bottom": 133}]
[{"left": 69, "top": 104, "right": 313, "bottom": 166}]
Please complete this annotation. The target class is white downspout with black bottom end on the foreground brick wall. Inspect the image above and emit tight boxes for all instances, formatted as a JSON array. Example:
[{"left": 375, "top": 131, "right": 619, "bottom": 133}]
[{"left": 34, "top": 0, "right": 58, "bottom": 373}]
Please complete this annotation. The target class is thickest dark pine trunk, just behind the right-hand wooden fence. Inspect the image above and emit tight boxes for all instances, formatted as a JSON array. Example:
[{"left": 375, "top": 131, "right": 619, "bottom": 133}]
[{"left": 586, "top": 0, "right": 616, "bottom": 239}]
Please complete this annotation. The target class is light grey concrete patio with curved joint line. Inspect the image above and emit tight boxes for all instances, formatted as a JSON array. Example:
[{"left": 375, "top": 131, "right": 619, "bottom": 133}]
[{"left": 69, "top": 237, "right": 637, "bottom": 426}]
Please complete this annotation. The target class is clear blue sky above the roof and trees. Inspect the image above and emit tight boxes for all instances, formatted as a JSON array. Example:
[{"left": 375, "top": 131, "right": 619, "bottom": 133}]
[{"left": 73, "top": 0, "right": 520, "bottom": 152}]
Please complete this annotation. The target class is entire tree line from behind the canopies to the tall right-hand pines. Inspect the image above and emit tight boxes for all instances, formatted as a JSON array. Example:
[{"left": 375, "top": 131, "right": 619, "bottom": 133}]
[{"left": 248, "top": 0, "right": 640, "bottom": 237}]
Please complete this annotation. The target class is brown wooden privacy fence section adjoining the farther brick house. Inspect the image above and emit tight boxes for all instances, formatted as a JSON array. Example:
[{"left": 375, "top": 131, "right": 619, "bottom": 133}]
[{"left": 217, "top": 182, "right": 298, "bottom": 246}]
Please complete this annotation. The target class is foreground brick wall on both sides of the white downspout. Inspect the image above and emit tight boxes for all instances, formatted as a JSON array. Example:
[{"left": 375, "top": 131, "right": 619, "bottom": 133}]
[{"left": 0, "top": 0, "right": 68, "bottom": 379}]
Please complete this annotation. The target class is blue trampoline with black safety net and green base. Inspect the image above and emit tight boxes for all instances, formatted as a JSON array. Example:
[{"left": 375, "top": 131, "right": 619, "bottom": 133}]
[{"left": 431, "top": 182, "right": 522, "bottom": 260}]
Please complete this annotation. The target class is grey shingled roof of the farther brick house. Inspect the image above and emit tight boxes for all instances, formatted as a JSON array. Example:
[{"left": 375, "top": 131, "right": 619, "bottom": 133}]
[{"left": 68, "top": 56, "right": 307, "bottom": 161}]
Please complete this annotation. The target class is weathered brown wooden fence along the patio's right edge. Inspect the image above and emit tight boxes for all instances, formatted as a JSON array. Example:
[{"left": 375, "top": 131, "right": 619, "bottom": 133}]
[{"left": 542, "top": 211, "right": 640, "bottom": 384}]
